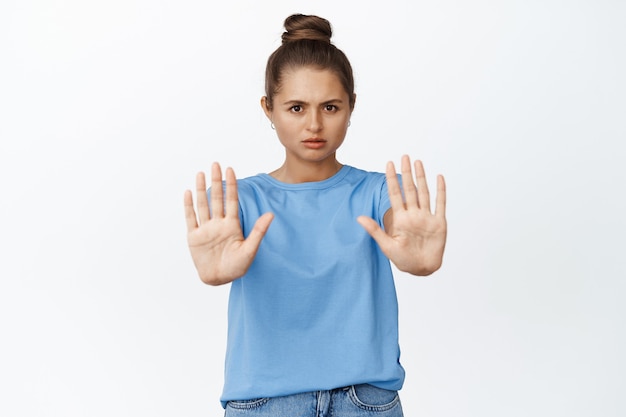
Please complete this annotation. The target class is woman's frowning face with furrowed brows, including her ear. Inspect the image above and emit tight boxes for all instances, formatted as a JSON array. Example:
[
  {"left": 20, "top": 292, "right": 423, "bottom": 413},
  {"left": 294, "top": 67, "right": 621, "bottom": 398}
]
[{"left": 262, "top": 67, "right": 352, "bottom": 167}]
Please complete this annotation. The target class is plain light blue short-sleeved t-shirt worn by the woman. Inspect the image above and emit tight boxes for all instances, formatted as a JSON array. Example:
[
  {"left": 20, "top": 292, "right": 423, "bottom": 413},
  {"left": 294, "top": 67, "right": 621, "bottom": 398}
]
[{"left": 221, "top": 166, "right": 404, "bottom": 405}]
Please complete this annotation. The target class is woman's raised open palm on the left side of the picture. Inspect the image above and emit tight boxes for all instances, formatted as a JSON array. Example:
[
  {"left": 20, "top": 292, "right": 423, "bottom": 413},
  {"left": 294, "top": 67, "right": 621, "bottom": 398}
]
[{"left": 184, "top": 163, "right": 274, "bottom": 285}]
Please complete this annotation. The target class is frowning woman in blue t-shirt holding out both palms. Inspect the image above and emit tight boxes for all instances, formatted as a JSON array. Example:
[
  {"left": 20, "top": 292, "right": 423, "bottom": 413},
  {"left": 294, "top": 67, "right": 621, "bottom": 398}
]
[{"left": 184, "top": 15, "right": 447, "bottom": 417}]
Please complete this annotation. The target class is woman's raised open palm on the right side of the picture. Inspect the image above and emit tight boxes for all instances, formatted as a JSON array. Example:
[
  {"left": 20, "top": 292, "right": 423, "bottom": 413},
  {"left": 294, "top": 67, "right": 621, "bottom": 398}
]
[{"left": 357, "top": 155, "right": 447, "bottom": 276}]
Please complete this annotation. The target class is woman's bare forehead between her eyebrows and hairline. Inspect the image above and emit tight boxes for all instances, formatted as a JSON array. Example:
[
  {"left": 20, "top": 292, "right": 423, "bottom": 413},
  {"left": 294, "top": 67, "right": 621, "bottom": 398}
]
[{"left": 276, "top": 67, "right": 347, "bottom": 101}]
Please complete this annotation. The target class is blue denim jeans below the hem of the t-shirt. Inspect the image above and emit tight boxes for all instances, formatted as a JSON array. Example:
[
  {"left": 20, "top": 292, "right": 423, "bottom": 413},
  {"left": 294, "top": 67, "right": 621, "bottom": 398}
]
[{"left": 225, "top": 384, "right": 403, "bottom": 417}]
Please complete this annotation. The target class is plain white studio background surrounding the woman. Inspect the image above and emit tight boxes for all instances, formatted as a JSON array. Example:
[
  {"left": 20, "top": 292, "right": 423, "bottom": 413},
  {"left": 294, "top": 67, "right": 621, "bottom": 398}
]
[{"left": 0, "top": 0, "right": 626, "bottom": 417}]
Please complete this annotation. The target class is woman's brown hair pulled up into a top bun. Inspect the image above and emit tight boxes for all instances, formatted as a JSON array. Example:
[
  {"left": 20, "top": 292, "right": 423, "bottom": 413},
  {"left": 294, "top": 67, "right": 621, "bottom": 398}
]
[{"left": 265, "top": 14, "right": 354, "bottom": 110}]
